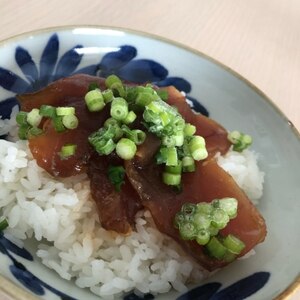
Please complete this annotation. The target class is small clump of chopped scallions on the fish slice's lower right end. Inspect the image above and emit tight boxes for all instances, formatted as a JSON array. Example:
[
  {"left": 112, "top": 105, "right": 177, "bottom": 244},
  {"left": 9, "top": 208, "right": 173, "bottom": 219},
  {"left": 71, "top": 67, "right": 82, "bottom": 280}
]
[{"left": 173, "top": 198, "right": 245, "bottom": 261}]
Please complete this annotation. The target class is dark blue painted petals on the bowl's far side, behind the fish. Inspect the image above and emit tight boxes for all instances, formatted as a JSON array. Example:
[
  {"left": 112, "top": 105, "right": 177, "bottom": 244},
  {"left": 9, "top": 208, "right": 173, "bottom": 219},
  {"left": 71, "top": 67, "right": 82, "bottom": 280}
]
[{"left": 0, "top": 33, "right": 208, "bottom": 119}]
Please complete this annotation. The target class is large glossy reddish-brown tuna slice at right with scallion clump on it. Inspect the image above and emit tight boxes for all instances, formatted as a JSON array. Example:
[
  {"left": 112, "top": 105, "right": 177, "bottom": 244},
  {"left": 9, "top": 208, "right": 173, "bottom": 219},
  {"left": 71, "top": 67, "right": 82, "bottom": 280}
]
[{"left": 125, "top": 138, "right": 266, "bottom": 270}]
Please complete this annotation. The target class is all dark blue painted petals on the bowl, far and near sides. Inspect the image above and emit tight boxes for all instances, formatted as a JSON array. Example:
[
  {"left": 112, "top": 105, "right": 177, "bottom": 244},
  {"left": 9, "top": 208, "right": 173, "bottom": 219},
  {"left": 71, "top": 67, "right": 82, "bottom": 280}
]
[{"left": 0, "top": 33, "right": 270, "bottom": 300}]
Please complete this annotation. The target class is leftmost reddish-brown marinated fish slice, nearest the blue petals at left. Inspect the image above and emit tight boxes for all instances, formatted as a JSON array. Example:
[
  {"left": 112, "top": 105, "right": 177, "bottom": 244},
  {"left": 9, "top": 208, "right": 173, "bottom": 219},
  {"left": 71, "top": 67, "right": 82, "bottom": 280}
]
[{"left": 18, "top": 75, "right": 109, "bottom": 177}]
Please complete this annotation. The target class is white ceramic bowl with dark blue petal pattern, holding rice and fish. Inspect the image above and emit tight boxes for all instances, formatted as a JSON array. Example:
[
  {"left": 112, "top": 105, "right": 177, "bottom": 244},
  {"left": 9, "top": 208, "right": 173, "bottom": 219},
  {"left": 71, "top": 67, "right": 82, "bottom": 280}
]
[{"left": 0, "top": 26, "right": 300, "bottom": 300}]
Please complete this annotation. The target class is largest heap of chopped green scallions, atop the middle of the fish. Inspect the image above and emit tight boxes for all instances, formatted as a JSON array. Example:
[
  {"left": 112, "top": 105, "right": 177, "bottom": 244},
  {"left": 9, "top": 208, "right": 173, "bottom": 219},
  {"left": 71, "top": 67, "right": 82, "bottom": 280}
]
[{"left": 85, "top": 75, "right": 208, "bottom": 188}]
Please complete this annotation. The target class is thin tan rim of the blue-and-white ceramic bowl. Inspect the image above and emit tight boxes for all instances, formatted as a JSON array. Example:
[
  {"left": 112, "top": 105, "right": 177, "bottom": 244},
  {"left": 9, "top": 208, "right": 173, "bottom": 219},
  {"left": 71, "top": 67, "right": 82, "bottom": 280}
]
[{"left": 0, "top": 24, "right": 300, "bottom": 300}]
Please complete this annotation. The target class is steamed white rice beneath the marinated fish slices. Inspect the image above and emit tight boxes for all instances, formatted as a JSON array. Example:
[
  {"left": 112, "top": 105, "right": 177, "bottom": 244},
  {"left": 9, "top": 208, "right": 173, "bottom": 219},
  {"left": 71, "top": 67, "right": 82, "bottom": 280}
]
[{"left": 0, "top": 109, "right": 263, "bottom": 299}]
